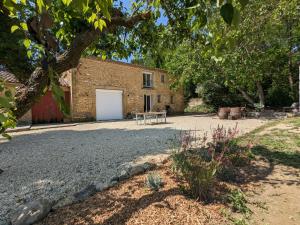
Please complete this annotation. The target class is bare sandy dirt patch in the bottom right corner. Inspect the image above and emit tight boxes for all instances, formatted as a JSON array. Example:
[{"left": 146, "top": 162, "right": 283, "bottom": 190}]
[{"left": 249, "top": 165, "right": 300, "bottom": 225}]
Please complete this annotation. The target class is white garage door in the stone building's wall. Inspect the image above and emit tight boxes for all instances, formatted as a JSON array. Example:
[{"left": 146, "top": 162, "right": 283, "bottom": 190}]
[{"left": 96, "top": 89, "right": 123, "bottom": 120}]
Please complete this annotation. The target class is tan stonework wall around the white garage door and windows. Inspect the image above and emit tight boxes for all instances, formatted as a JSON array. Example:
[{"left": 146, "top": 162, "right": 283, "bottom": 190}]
[{"left": 71, "top": 58, "right": 184, "bottom": 121}]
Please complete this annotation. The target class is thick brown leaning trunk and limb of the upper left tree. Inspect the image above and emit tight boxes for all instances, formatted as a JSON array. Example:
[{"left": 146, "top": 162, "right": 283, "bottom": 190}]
[{"left": 15, "top": 12, "right": 151, "bottom": 118}]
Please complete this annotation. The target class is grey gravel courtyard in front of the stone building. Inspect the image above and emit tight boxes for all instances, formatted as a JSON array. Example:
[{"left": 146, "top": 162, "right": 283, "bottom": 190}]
[{"left": 0, "top": 115, "right": 265, "bottom": 225}]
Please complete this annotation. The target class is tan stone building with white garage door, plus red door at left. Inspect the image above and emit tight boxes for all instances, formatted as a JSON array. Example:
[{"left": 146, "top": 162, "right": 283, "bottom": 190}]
[{"left": 0, "top": 57, "right": 184, "bottom": 123}]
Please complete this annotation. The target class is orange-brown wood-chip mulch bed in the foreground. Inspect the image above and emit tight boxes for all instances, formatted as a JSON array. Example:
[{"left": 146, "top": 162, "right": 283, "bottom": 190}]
[{"left": 38, "top": 162, "right": 227, "bottom": 225}]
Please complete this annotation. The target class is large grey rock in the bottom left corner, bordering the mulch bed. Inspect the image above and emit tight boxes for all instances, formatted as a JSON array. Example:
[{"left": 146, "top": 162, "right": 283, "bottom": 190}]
[{"left": 11, "top": 199, "right": 52, "bottom": 225}]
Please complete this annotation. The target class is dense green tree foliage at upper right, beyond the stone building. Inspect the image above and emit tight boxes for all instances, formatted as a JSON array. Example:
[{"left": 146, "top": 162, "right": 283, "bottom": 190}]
[{"left": 164, "top": 0, "right": 300, "bottom": 106}]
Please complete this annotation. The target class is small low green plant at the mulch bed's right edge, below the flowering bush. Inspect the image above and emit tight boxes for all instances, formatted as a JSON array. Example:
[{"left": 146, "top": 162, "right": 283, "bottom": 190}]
[{"left": 227, "top": 189, "right": 251, "bottom": 214}]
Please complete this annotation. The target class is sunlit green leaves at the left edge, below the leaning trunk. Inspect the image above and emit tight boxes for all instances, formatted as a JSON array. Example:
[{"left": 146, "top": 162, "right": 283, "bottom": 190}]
[{"left": 0, "top": 80, "right": 16, "bottom": 138}]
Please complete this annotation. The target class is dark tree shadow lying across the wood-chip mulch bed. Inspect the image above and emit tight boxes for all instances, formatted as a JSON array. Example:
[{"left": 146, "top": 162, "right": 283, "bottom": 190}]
[{"left": 39, "top": 183, "right": 181, "bottom": 225}]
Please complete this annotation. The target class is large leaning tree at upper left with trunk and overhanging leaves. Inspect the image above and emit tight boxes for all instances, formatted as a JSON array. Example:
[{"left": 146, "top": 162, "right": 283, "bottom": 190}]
[{"left": 0, "top": 0, "right": 251, "bottom": 135}]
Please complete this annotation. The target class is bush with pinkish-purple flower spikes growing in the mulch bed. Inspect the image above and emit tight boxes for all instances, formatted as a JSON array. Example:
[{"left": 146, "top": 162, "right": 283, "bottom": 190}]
[{"left": 172, "top": 126, "right": 248, "bottom": 202}]
